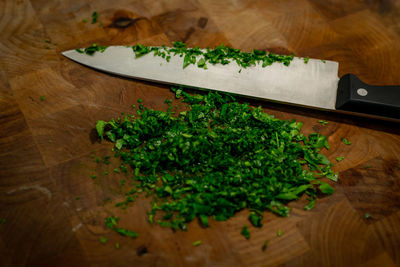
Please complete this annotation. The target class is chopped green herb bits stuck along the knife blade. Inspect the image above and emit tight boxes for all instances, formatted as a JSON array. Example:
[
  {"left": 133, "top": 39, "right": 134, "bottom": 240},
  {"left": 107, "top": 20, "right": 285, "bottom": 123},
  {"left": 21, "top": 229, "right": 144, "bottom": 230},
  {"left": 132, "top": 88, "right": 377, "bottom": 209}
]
[{"left": 79, "top": 41, "right": 296, "bottom": 69}]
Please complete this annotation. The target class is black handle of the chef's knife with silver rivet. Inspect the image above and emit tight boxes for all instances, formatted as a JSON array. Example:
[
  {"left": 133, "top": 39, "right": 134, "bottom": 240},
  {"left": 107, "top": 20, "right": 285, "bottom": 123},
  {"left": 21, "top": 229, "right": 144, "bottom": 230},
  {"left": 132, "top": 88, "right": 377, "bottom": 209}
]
[{"left": 336, "top": 74, "right": 400, "bottom": 119}]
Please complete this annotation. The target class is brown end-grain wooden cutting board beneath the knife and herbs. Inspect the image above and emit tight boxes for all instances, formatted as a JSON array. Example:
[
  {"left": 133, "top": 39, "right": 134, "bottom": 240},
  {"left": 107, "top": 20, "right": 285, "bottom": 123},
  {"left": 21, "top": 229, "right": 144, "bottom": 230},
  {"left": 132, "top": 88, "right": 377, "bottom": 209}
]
[{"left": 0, "top": 0, "right": 400, "bottom": 266}]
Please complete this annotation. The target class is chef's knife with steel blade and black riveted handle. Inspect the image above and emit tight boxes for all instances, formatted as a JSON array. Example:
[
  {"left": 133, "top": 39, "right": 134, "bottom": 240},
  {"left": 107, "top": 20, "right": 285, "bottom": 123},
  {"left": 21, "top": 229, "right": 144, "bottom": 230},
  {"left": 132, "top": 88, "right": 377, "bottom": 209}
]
[{"left": 62, "top": 46, "right": 400, "bottom": 120}]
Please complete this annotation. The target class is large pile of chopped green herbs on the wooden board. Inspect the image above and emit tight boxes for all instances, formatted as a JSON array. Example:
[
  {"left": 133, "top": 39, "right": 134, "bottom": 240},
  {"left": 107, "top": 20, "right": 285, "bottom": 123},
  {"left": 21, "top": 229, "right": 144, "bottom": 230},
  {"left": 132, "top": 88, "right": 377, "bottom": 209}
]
[{"left": 96, "top": 88, "right": 337, "bottom": 230}]
